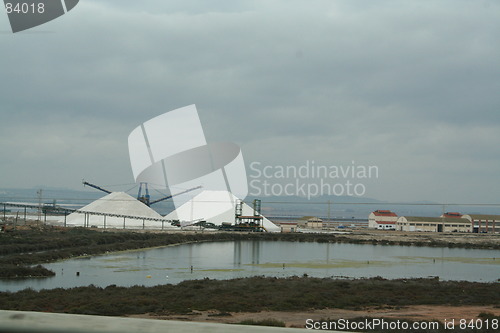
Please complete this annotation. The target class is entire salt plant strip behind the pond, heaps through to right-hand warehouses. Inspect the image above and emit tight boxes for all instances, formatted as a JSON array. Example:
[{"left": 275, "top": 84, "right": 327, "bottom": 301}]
[{"left": 0, "top": 181, "right": 500, "bottom": 235}]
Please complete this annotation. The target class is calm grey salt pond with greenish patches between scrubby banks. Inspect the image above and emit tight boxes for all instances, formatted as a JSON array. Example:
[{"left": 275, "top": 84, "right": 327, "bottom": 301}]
[{"left": 0, "top": 241, "right": 500, "bottom": 291}]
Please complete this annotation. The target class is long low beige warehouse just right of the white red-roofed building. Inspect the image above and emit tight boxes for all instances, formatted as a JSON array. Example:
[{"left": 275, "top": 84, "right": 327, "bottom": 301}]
[{"left": 396, "top": 216, "right": 472, "bottom": 232}]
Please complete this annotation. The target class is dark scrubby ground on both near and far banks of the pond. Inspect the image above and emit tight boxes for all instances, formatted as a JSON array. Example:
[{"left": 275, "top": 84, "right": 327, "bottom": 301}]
[{"left": 0, "top": 228, "right": 500, "bottom": 332}]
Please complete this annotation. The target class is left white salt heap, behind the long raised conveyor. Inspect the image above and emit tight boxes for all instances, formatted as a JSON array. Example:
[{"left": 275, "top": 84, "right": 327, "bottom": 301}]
[{"left": 60, "top": 192, "right": 175, "bottom": 229}]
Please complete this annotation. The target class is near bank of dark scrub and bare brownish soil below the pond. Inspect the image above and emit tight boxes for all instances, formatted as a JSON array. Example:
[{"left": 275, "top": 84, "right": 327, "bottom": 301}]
[{"left": 0, "top": 277, "right": 500, "bottom": 332}]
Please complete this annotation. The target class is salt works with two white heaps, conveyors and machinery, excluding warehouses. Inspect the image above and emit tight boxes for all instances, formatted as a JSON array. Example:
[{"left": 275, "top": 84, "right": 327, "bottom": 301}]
[{"left": 2, "top": 181, "right": 280, "bottom": 232}]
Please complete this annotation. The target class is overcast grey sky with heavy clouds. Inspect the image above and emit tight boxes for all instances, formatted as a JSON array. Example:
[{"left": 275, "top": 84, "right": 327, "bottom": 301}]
[{"left": 0, "top": 0, "right": 500, "bottom": 203}]
